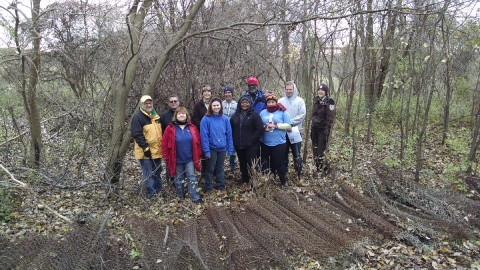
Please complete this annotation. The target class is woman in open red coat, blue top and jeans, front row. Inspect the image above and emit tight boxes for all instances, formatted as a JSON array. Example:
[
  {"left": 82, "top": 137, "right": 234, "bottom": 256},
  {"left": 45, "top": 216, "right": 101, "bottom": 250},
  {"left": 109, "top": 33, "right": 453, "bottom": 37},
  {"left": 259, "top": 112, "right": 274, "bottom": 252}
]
[{"left": 162, "top": 107, "right": 202, "bottom": 203}]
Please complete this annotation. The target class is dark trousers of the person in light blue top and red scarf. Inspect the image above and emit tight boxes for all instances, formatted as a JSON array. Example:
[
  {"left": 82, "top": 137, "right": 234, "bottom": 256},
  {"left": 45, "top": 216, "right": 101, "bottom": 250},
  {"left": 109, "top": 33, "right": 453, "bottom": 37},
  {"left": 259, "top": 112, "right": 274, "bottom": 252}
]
[{"left": 260, "top": 143, "right": 287, "bottom": 184}]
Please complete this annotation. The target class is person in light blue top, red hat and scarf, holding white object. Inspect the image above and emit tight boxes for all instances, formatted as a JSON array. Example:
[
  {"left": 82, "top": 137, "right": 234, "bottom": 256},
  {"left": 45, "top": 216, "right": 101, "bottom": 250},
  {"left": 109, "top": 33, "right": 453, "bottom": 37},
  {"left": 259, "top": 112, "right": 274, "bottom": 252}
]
[{"left": 260, "top": 93, "right": 292, "bottom": 187}]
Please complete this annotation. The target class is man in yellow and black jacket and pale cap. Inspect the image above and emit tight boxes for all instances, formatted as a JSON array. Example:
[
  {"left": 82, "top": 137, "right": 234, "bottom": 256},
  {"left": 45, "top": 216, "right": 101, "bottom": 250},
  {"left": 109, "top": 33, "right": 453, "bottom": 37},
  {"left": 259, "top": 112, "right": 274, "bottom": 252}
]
[{"left": 131, "top": 95, "right": 162, "bottom": 198}]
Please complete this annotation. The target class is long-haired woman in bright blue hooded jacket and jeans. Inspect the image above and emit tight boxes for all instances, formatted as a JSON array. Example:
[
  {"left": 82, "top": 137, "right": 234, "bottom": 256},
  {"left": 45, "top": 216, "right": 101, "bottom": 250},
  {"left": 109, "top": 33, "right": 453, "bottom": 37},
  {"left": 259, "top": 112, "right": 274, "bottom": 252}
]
[{"left": 200, "top": 97, "right": 233, "bottom": 194}]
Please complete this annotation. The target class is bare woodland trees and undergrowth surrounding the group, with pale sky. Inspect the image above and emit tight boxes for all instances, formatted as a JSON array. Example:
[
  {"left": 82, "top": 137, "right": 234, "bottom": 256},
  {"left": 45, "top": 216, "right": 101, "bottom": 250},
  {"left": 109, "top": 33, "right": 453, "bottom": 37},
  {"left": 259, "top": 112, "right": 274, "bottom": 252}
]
[{"left": 0, "top": 0, "right": 480, "bottom": 268}]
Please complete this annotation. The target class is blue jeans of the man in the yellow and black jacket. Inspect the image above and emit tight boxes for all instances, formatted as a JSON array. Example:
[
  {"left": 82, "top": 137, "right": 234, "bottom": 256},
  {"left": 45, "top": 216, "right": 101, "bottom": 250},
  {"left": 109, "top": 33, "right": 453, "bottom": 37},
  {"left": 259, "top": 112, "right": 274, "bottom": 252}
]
[{"left": 140, "top": 158, "right": 162, "bottom": 198}]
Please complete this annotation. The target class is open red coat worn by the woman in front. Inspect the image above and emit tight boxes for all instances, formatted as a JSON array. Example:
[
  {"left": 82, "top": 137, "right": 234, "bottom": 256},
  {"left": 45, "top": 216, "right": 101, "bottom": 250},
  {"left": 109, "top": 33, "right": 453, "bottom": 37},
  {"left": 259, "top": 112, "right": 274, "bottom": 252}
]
[{"left": 162, "top": 122, "right": 202, "bottom": 176}]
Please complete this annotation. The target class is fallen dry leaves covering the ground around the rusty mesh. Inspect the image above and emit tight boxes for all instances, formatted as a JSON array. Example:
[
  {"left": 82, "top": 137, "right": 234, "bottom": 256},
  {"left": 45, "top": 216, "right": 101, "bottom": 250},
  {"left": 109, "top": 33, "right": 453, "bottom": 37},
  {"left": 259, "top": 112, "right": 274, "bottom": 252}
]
[{"left": 0, "top": 126, "right": 480, "bottom": 269}]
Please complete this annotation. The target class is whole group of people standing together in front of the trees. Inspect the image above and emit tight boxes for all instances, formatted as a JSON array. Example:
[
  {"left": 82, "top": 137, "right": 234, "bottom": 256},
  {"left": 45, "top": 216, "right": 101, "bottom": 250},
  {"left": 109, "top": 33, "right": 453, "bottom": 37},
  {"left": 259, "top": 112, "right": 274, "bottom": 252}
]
[{"left": 131, "top": 77, "right": 335, "bottom": 203}]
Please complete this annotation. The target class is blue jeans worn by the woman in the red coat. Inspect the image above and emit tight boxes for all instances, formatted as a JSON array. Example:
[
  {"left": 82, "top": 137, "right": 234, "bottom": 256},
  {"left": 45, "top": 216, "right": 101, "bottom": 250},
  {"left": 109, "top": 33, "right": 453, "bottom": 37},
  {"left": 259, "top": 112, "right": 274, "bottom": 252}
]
[{"left": 175, "top": 161, "right": 200, "bottom": 201}]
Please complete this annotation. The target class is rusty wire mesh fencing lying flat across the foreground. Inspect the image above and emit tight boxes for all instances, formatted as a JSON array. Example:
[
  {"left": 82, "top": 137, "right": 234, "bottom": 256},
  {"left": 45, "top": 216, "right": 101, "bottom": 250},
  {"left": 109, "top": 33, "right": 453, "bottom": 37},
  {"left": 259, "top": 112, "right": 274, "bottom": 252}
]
[{"left": 0, "top": 164, "right": 480, "bottom": 269}]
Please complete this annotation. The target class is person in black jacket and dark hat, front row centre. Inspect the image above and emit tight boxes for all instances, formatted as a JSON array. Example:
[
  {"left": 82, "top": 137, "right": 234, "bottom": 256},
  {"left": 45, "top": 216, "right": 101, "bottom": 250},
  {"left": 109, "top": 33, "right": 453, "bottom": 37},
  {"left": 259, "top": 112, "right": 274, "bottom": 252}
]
[{"left": 230, "top": 96, "right": 263, "bottom": 183}]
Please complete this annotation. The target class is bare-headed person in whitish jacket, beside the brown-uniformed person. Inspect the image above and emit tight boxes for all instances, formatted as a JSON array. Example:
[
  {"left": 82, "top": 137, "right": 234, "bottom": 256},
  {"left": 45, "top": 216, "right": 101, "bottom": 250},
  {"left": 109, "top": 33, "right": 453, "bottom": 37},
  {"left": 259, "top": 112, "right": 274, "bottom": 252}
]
[{"left": 278, "top": 81, "right": 307, "bottom": 183}]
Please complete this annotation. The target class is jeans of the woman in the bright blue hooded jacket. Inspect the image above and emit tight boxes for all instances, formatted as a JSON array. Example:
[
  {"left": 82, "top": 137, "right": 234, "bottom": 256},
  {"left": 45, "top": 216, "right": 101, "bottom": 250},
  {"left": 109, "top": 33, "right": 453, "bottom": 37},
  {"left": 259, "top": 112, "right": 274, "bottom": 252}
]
[{"left": 204, "top": 149, "right": 227, "bottom": 191}]
